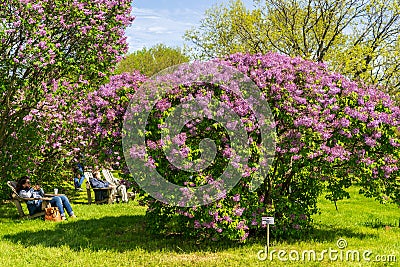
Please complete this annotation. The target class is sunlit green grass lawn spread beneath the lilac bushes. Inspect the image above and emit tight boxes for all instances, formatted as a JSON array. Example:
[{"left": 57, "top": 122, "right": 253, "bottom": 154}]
[{"left": 0, "top": 189, "right": 400, "bottom": 266}]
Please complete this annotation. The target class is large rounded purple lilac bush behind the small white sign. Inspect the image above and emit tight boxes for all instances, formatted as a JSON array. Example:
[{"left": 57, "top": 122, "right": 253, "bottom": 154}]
[{"left": 73, "top": 53, "right": 400, "bottom": 241}]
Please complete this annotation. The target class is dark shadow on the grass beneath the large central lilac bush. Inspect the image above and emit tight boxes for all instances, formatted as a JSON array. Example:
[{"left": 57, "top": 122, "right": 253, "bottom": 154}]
[{"left": 3, "top": 215, "right": 378, "bottom": 253}]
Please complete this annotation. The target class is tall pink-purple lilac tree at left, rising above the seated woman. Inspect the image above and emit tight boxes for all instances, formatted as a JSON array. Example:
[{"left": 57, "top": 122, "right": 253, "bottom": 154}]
[{"left": 0, "top": 0, "right": 133, "bottom": 199}]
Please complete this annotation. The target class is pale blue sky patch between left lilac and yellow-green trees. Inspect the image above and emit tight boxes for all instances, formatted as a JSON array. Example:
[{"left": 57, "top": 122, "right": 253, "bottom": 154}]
[{"left": 126, "top": 0, "right": 253, "bottom": 52}]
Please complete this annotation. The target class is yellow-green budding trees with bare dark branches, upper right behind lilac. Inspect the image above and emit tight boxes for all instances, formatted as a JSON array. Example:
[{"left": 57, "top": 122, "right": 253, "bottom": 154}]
[{"left": 185, "top": 0, "right": 400, "bottom": 100}]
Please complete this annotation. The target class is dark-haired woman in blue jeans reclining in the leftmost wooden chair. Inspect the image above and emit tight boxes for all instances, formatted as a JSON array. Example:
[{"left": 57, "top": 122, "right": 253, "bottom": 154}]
[{"left": 16, "top": 176, "right": 76, "bottom": 220}]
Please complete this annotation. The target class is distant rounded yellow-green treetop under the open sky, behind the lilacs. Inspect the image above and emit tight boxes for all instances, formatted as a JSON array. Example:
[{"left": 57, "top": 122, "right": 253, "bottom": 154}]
[{"left": 115, "top": 44, "right": 189, "bottom": 77}]
